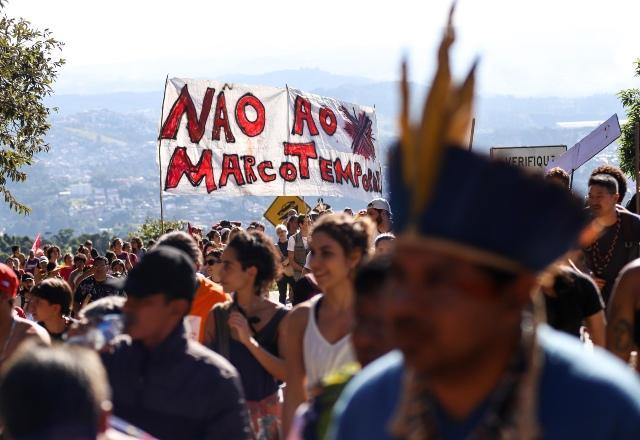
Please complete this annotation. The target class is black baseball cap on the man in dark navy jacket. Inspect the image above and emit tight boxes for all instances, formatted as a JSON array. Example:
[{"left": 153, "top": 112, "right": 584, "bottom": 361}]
[{"left": 109, "top": 245, "right": 198, "bottom": 301}]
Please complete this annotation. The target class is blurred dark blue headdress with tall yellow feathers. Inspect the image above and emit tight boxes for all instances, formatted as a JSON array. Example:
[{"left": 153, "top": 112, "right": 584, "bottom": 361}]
[{"left": 389, "top": 7, "right": 586, "bottom": 272}]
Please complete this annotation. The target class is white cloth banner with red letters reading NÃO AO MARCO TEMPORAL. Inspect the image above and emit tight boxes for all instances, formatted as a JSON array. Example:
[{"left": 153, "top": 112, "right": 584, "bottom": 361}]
[{"left": 159, "top": 78, "right": 382, "bottom": 200}]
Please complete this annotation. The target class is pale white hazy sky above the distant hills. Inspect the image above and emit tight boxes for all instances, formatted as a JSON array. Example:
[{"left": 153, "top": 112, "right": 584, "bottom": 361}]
[{"left": 5, "top": 0, "right": 640, "bottom": 96}]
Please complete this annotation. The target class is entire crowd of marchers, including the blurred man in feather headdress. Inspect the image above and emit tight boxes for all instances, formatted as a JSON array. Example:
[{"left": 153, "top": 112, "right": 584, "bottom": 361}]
[{"left": 0, "top": 18, "right": 640, "bottom": 440}]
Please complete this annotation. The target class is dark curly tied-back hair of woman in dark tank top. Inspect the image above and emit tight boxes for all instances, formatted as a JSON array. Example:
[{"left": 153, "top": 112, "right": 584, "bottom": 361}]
[{"left": 227, "top": 230, "right": 281, "bottom": 295}]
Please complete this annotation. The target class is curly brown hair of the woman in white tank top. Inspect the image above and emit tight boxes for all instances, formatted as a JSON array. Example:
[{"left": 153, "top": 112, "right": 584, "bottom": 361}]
[{"left": 312, "top": 213, "right": 373, "bottom": 264}]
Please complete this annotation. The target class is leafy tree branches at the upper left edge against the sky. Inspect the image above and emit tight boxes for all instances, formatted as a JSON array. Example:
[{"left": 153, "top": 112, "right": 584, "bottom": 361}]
[{"left": 0, "top": 11, "right": 64, "bottom": 214}]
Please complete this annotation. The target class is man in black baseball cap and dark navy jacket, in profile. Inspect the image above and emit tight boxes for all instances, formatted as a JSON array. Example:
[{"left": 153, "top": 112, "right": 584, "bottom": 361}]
[{"left": 103, "top": 246, "right": 251, "bottom": 439}]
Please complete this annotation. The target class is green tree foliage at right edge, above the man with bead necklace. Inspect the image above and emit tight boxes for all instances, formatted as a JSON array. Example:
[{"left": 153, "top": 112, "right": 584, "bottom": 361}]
[{"left": 618, "top": 58, "right": 640, "bottom": 180}]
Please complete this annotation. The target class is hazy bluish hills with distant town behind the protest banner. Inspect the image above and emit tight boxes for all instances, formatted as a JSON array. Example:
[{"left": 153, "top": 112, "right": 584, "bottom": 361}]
[{"left": 0, "top": 69, "right": 624, "bottom": 235}]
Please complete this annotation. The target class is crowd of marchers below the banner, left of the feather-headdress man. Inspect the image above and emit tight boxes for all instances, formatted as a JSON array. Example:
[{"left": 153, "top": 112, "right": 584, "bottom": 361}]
[{"left": 0, "top": 199, "right": 395, "bottom": 439}]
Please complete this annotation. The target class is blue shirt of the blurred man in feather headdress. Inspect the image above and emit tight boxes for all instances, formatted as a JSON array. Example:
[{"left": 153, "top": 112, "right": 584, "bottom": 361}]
[{"left": 333, "top": 326, "right": 640, "bottom": 440}]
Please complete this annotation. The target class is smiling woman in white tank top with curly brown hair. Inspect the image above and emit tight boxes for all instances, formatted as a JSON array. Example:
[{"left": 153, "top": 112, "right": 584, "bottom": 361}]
[{"left": 282, "top": 214, "right": 372, "bottom": 438}]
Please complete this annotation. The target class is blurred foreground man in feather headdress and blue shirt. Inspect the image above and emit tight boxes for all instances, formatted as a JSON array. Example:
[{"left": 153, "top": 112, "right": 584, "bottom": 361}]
[{"left": 333, "top": 12, "right": 640, "bottom": 440}]
